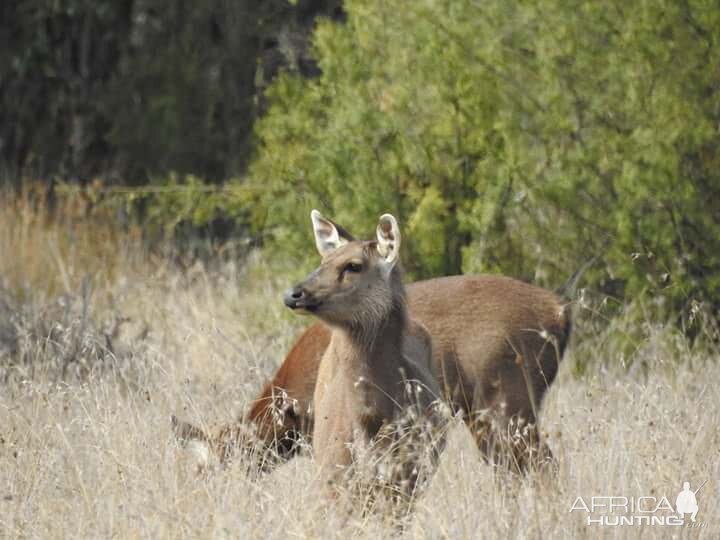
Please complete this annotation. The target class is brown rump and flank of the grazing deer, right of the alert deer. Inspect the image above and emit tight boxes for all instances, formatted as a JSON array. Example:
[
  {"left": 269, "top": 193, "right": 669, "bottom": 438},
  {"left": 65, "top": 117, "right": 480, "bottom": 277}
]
[{"left": 412, "top": 276, "right": 570, "bottom": 422}]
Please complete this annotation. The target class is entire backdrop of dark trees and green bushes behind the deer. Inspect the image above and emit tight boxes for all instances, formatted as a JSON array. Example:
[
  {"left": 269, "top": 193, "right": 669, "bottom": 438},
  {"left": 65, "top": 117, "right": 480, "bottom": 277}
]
[{"left": 0, "top": 0, "right": 720, "bottom": 324}]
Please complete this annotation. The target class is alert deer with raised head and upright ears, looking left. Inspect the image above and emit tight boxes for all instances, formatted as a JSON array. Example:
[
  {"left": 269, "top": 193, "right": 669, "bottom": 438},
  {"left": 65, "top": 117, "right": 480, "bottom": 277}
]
[{"left": 285, "top": 210, "right": 443, "bottom": 495}]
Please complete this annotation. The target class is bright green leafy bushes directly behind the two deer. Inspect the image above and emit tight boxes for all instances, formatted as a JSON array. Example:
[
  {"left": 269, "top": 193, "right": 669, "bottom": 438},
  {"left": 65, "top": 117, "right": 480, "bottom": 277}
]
[{"left": 251, "top": 0, "right": 720, "bottom": 313}]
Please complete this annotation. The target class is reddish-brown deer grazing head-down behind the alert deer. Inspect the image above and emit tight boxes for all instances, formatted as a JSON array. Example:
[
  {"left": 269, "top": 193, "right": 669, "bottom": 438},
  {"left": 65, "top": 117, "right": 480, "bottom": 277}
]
[{"left": 176, "top": 219, "right": 582, "bottom": 469}]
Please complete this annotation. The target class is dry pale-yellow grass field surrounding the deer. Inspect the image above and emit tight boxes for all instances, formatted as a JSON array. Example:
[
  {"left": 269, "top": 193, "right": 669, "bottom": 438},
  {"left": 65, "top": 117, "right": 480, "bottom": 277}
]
[{"left": 0, "top": 193, "right": 720, "bottom": 538}]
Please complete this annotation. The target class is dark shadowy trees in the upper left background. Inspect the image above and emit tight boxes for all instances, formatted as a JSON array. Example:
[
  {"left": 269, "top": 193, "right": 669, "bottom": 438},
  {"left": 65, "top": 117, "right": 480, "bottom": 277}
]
[{"left": 0, "top": 0, "right": 340, "bottom": 181}]
